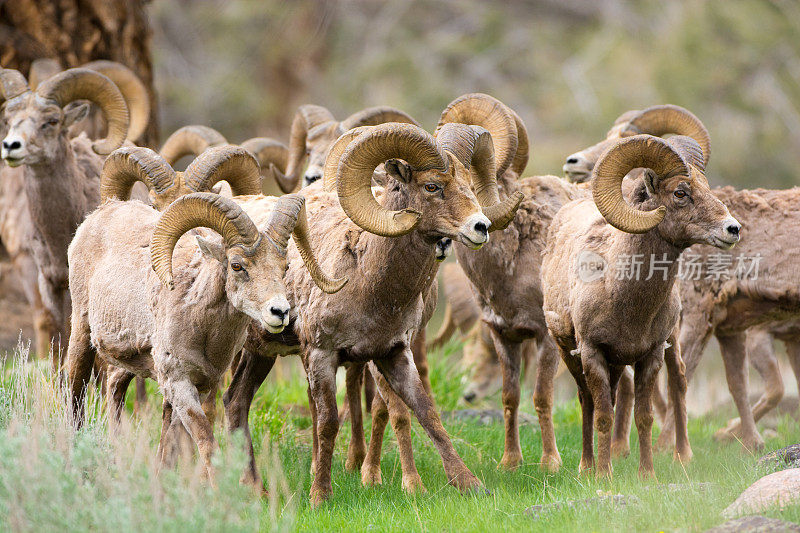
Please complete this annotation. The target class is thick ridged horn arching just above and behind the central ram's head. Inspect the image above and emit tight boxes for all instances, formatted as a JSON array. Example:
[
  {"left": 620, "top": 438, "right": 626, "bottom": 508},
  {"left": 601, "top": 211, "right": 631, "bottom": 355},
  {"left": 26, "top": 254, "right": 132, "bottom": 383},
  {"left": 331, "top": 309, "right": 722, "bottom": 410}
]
[{"left": 437, "top": 93, "right": 519, "bottom": 176}]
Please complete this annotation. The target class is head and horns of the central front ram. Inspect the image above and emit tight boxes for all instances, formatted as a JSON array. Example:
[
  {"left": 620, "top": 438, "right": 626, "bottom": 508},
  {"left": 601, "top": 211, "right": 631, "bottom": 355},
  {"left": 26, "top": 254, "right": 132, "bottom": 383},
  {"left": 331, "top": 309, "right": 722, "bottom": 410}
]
[{"left": 325, "top": 123, "right": 518, "bottom": 248}]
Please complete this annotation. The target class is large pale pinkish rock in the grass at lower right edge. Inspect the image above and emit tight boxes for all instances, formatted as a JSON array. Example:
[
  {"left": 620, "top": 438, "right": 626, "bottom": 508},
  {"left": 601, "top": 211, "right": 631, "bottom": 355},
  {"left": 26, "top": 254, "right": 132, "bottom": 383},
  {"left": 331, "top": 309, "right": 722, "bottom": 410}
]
[{"left": 722, "top": 468, "right": 800, "bottom": 518}]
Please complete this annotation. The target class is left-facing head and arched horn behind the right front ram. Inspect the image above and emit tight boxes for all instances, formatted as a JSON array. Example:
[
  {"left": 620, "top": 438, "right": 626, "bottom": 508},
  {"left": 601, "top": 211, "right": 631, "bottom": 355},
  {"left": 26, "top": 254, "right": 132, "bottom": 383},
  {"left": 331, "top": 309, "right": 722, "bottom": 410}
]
[{"left": 563, "top": 104, "right": 711, "bottom": 183}]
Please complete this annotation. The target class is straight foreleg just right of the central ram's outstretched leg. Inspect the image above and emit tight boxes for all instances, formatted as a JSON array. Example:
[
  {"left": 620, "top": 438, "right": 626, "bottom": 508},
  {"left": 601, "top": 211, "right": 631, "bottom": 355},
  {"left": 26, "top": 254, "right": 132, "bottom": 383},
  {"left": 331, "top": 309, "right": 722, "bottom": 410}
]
[{"left": 491, "top": 328, "right": 522, "bottom": 470}]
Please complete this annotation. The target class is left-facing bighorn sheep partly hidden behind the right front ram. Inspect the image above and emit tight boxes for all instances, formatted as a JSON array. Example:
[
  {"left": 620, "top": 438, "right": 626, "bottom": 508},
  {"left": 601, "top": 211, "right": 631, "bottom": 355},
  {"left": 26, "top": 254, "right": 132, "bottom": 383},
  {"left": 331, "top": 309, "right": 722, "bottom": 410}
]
[{"left": 564, "top": 106, "right": 800, "bottom": 448}]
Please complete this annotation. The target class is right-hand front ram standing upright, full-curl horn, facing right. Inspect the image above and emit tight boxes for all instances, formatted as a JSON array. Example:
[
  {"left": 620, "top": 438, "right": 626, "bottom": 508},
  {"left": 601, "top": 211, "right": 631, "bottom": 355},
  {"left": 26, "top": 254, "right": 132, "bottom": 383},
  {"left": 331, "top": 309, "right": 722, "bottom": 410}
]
[{"left": 542, "top": 135, "right": 741, "bottom": 477}]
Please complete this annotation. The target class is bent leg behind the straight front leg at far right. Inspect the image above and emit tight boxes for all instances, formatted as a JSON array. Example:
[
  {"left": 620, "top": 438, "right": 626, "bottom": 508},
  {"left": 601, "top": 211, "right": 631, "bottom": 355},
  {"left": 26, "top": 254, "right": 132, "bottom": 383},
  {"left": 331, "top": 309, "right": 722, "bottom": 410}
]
[{"left": 725, "top": 328, "right": 783, "bottom": 435}]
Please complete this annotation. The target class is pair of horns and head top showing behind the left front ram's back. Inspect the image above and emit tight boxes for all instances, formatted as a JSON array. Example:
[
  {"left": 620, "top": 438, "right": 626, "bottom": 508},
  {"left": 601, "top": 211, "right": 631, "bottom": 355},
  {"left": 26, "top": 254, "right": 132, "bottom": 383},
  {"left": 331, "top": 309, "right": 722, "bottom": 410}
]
[{"left": 100, "top": 145, "right": 261, "bottom": 211}]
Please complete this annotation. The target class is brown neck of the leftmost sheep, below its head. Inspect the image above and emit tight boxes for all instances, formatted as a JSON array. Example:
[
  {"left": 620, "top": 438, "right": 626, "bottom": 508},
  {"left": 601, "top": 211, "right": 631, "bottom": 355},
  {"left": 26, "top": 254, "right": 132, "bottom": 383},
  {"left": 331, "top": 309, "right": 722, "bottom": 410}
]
[{"left": 24, "top": 139, "right": 88, "bottom": 265}]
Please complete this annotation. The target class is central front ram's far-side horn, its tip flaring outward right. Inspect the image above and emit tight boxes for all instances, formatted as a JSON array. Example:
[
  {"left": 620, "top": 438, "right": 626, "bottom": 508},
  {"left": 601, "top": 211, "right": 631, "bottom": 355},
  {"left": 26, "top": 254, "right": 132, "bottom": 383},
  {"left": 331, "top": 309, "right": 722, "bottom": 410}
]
[{"left": 436, "top": 123, "right": 524, "bottom": 231}]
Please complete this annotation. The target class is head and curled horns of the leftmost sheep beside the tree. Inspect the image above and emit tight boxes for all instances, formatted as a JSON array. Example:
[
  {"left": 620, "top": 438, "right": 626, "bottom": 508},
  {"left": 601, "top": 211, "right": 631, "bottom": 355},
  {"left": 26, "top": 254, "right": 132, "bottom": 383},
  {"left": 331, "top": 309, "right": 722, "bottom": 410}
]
[{"left": 0, "top": 68, "right": 129, "bottom": 166}]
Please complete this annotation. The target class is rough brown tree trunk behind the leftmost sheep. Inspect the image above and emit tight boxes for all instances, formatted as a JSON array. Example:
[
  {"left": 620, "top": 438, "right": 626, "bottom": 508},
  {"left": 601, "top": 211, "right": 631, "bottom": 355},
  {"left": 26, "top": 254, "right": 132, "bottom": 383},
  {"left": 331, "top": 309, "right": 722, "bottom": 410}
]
[{"left": 0, "top": 0, "right": 159, "bottom": 148}]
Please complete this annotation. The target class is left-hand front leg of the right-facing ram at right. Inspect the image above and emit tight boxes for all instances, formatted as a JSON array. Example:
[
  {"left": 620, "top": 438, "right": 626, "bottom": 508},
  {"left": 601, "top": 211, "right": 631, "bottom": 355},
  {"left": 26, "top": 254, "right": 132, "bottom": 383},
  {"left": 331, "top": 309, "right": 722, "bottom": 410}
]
[{"left": 580, "top": 343, "right": 614, "bottom": 477}]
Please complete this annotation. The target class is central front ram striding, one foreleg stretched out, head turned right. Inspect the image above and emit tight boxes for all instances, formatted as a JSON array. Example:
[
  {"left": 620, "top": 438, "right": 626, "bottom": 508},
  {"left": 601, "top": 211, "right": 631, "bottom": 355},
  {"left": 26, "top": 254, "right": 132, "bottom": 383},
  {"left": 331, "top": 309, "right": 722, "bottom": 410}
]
[{"left": 224, "top": 123, "right": 521, "bottom": 505}]
